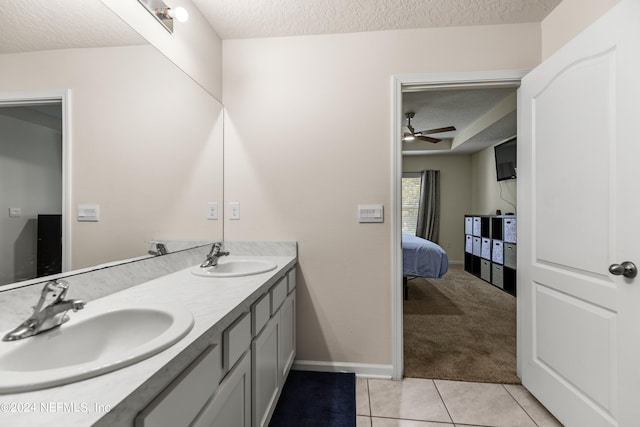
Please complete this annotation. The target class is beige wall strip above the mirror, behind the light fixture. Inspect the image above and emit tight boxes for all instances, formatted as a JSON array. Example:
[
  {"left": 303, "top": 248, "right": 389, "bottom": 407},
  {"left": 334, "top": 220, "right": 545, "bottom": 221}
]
[{"left": 100, "top": 0, "right": 222, "bottom": 99}]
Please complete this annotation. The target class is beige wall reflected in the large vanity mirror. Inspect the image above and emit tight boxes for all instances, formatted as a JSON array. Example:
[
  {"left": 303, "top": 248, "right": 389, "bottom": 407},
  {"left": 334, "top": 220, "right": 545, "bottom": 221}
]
[{"left": 0, "top": 45, "right": 223, "bottom": 269}]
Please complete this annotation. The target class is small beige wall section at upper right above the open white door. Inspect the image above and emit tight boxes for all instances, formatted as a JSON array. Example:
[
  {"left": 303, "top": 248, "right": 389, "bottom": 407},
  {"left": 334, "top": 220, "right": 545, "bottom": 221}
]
[{"left": 541, "top": 0, "right": 620, "bottom": 60}]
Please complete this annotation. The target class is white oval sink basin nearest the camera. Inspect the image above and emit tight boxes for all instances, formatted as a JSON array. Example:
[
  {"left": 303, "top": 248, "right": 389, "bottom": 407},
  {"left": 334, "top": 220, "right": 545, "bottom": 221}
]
[{"left": 0, "top": 300, "right": 193, "bottom": 393}]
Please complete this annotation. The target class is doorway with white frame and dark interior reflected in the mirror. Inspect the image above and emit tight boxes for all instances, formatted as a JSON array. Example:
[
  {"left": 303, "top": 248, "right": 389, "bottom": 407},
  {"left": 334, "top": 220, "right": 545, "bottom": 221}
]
[{"left": 0, "top": 91, "right": 70, "bottom": 285}]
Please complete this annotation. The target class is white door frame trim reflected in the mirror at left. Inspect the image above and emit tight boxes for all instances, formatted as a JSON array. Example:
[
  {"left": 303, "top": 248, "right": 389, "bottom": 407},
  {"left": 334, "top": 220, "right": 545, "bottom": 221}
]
[{"left": 0, "top": 89, "right": 72, "bottom": 272}]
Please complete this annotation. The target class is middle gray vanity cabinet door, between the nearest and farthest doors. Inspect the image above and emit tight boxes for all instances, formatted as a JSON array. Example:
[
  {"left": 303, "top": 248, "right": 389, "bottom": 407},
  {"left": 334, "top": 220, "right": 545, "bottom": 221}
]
[{"left": 251, "top": 314, "right": 281, "bottom": 427}]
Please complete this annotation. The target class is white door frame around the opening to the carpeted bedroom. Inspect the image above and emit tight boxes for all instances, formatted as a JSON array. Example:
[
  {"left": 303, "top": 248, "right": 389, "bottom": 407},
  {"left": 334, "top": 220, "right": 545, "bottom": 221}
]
[{"left": 391, "top": 69, "right": 530, "bottom": 380}]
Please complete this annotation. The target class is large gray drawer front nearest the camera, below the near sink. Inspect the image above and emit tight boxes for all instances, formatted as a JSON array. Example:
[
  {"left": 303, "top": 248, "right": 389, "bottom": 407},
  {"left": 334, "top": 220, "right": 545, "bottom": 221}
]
[{"left": 134, "top": 345, "right": 222, "bottom": 427}]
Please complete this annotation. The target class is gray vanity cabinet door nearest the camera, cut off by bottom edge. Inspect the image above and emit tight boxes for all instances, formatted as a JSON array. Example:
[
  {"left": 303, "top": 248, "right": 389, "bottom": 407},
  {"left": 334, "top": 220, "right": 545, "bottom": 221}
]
[{"left": 191, "top": 352, "right": 251, "bottom": 427}]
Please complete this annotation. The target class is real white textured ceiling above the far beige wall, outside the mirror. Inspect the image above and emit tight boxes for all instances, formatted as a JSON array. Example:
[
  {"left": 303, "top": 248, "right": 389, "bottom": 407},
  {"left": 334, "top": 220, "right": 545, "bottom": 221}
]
[{"left": 193, "top": 0, "right": 561, "bottom": 39}]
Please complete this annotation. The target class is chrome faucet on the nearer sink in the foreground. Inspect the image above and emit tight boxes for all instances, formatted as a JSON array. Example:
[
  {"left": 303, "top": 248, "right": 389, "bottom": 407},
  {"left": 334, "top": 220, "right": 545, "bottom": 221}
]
[{"left": 2, "top": 280, "right": 86, "bottom": 341}]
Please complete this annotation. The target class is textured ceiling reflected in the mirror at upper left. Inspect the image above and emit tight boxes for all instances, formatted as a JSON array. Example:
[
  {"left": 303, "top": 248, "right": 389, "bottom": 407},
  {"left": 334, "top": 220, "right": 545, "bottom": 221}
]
[{"left": 0, "top": 0, "right": 147, "bottom": 53}]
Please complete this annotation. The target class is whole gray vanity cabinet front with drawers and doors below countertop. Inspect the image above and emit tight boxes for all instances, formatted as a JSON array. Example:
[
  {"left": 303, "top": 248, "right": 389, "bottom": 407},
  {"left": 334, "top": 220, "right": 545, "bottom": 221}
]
[{"left": 135, "top": 268, "right": 296, "bottom": 427}]
